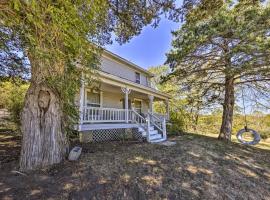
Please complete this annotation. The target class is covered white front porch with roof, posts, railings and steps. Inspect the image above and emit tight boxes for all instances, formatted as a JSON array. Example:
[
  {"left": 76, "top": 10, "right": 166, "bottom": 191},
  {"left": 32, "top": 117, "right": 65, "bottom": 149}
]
[{"left": 78, "top": 72, "right": 169, "bottom": 141}]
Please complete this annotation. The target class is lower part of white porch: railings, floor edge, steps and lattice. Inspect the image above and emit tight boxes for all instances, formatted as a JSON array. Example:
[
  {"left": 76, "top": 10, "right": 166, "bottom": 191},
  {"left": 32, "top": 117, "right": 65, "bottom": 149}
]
[{"left": 80, "top": 107, "right": 167, "bottom": 143}]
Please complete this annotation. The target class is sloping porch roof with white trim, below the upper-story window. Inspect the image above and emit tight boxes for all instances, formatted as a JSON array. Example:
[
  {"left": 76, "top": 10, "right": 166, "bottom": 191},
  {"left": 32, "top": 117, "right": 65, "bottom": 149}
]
[{"left": 98, "top": 71, "right": 171, "bottom": 100}]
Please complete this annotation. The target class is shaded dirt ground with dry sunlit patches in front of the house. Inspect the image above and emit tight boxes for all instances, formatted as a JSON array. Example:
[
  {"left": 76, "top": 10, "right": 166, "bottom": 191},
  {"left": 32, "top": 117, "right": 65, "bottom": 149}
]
[{"left": 0, "top": 133, "right": 270, "bottom": 200}]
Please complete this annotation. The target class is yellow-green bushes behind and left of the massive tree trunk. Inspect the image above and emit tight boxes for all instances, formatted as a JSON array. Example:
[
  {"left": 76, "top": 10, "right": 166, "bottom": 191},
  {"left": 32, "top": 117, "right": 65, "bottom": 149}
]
[{"left": 0, "top": 80, "right": 29, "bottom": 126}]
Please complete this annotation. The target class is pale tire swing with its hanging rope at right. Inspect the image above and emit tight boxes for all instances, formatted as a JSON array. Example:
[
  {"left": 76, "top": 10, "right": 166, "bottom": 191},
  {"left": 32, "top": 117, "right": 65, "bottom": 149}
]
[{"left": 236, "top": 88, "right": 261, "bottom": 145}]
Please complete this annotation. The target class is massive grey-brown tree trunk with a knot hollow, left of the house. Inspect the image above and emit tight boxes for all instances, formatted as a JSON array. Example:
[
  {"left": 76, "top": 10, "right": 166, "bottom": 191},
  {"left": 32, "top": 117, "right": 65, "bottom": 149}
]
[{"left": 20, "top": 82, "right": 67, "bottom": 170}]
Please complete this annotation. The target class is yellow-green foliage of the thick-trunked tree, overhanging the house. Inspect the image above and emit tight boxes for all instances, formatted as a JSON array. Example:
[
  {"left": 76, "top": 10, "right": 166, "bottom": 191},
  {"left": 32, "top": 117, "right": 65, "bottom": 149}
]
[{"left": 0, "top": 0, "right": 181, "bottom": 134}]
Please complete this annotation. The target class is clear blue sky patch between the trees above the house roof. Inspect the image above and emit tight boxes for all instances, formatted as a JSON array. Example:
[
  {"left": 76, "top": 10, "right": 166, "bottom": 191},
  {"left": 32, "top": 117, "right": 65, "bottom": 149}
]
[{"left": 106, "top": 18, "right": 180, "bottom": 69}]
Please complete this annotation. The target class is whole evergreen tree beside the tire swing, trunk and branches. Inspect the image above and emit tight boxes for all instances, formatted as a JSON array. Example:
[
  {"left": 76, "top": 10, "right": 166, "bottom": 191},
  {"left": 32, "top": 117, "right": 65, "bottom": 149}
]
[{"left": 166, "top": 0, "right": 270, "bottom": 138}]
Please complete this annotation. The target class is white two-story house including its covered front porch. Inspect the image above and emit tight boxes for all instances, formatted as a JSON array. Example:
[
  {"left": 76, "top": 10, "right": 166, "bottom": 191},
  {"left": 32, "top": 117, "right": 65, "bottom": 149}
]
[{"left": 78, "top": 51, "right": 170, "bottom": 142}]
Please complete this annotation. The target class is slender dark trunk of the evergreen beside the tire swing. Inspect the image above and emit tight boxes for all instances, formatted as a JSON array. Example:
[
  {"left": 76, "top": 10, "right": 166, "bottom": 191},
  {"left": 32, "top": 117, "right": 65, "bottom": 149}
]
[{"left": 218, "top": 77, "right": 235, "bottom": 141}]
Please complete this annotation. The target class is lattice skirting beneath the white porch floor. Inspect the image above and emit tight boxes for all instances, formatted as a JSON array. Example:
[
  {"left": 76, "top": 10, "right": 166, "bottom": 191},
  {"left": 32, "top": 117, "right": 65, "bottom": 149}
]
[{"left": 80, "top": 128, "right": 143, "bottom": 142}]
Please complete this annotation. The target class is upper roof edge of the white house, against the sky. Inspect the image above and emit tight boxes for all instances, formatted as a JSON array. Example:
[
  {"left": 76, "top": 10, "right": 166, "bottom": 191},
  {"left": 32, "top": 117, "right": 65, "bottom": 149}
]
[{"left": 103, "top": 49, "right": 155, "bottom": 77}]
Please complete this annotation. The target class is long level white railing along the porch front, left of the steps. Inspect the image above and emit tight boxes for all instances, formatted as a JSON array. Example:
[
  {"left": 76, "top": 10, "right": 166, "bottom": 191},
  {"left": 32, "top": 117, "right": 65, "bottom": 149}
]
[{"left": 83, "top": 107, "right": 132, "bottom": 123}]
